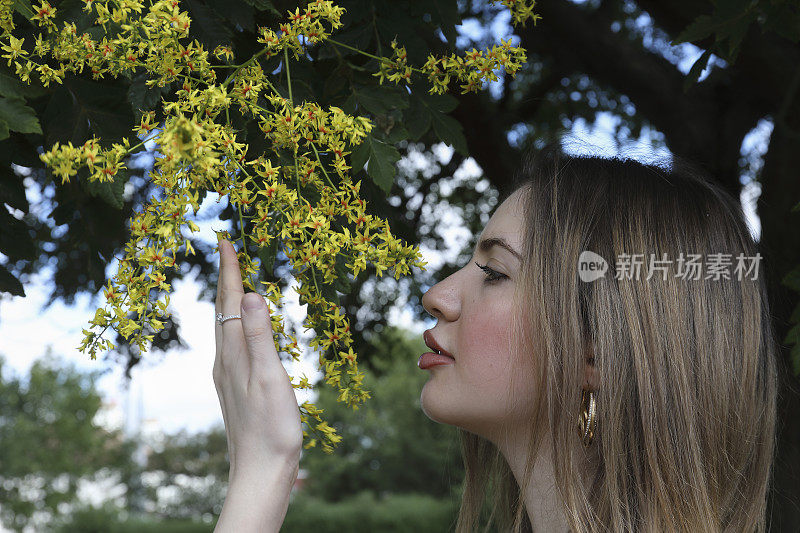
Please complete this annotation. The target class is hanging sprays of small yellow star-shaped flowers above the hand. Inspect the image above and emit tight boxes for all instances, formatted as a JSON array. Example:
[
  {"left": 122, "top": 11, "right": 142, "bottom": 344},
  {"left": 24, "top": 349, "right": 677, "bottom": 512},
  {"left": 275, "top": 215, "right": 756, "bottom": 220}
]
[{"left": 0, "top": 0, "right": 536, "bottom": 453}]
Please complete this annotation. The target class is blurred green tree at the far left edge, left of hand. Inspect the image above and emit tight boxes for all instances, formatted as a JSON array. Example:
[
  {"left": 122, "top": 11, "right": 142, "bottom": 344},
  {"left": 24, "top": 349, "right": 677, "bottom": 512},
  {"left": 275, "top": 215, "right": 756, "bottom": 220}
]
[{"left": 0, "top": 352, "right": 135, "bottom": 530}]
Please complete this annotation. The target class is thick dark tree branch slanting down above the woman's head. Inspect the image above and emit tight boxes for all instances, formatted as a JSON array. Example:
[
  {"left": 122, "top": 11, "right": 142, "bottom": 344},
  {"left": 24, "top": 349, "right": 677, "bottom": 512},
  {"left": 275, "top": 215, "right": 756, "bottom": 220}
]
[{"left": 520, "top": 1, "right": 765, "bottom": 197}]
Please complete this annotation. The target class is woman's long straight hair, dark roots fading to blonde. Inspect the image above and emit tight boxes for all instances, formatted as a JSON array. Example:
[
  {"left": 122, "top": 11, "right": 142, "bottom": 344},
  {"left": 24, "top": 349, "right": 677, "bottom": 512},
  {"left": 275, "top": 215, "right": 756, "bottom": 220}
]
[{"left": 456, "top": 145, "right": 777, "bottom": 533}]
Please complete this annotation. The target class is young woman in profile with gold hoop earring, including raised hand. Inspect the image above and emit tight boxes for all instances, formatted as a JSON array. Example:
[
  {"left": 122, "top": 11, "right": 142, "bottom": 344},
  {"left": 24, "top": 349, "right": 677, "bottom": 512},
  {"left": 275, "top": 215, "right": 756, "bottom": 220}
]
[{"left": 209, "top": 143, "right": 777, "bottom": 533}]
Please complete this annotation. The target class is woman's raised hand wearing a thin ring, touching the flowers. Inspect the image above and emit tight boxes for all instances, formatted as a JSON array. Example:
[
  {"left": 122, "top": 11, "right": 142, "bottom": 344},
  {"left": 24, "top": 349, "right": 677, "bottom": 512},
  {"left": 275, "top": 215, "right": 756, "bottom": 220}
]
[{"left": 214, "top": 239, "right": 303, "bottom": 484}]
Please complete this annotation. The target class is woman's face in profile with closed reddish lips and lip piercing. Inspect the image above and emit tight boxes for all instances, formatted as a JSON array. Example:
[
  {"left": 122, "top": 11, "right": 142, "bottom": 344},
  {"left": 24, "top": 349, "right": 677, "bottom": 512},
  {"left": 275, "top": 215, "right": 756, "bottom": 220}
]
[{"left": 420, "top": 190, "right": 533, "bottom": 440}]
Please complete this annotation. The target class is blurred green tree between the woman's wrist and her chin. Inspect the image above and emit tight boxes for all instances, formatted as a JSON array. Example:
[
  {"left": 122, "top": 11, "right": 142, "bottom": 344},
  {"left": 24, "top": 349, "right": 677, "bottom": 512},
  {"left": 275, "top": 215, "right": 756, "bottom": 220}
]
[{"left": 300, "top": 328, "right": 464, "bottom": 502}]
